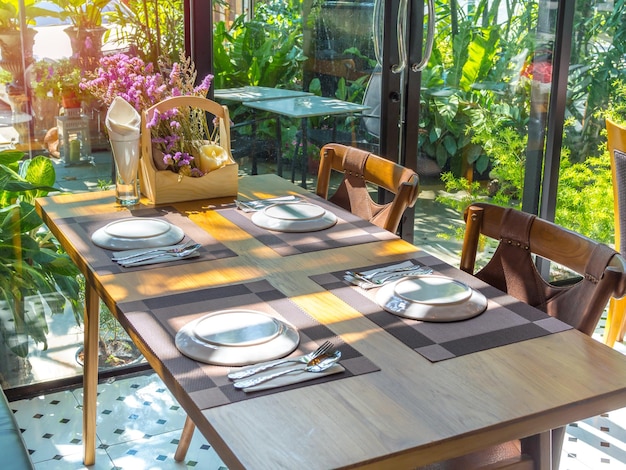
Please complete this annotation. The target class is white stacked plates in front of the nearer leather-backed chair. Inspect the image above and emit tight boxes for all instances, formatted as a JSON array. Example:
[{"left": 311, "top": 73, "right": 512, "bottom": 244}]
[{"left": 375, "top": 275, "right": 487, "bottom": 322}]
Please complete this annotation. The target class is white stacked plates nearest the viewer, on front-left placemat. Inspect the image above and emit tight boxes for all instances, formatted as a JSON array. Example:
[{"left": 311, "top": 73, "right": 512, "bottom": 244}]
[{"left": 176, "top": 309, "right": 300, "bottom": 366}]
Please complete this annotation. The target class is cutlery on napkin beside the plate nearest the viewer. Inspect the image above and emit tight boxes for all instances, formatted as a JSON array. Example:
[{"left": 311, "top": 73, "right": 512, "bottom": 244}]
[{"left": 228, "top": 341, "right": 341, "bottom": 389}]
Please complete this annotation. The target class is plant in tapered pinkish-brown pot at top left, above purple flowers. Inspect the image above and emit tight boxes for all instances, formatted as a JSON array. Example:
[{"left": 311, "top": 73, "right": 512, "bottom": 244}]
[{"left": 52, "top": 0, "right": 111, "bottom": 70}]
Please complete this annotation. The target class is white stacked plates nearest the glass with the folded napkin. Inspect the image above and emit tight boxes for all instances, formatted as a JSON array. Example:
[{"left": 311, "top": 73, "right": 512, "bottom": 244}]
[{"left": 91, "top": 217, "right": 185, "bottom": 250}]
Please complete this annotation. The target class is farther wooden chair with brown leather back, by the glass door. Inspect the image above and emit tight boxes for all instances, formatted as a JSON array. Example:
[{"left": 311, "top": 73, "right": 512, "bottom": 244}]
[{"left": 316, "top": 144, "right": 419, "bottom": 232}]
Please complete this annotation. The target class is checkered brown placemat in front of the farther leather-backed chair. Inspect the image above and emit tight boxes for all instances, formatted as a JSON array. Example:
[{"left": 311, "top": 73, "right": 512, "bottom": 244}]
[{"left": 218, "top": 194, "right": 398, "bottom": 256}]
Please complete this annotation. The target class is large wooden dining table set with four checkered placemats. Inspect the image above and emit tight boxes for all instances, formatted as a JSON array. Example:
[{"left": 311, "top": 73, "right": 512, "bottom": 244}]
[{"left": 37, "top": 175, "right": 626, "bottom": 469}]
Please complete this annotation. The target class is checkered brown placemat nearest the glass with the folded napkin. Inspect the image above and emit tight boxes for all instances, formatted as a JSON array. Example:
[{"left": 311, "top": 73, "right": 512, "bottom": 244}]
[{"left": 51, "top": 206, "right": 237, "bottom": 275}]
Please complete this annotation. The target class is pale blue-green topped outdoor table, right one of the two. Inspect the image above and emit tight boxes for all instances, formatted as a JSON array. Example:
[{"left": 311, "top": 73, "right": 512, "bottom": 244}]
[{"left": 243, "top": 95, "right": 368, "bottom": 188}]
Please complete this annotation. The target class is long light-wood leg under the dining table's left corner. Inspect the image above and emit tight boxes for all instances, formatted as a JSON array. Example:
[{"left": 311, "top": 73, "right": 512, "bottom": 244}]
[{"left": 83, "top": 282, "right": 100, "bottom": 465}]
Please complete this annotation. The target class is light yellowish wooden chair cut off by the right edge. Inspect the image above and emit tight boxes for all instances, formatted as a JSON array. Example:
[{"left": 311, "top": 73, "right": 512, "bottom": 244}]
[{"left": 604, "top": 119, "right": 626, "bottom": 347}]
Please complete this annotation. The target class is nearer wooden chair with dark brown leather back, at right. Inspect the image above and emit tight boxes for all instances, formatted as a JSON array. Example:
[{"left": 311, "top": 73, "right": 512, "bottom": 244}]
[{"left": 424, "top": 203, "right": 626, "bottom": 470}]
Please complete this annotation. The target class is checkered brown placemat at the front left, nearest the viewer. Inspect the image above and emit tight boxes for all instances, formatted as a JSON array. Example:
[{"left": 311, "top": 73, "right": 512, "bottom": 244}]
[{"left": 118, "top": 280, "right": 380, "bottom": 409}]
